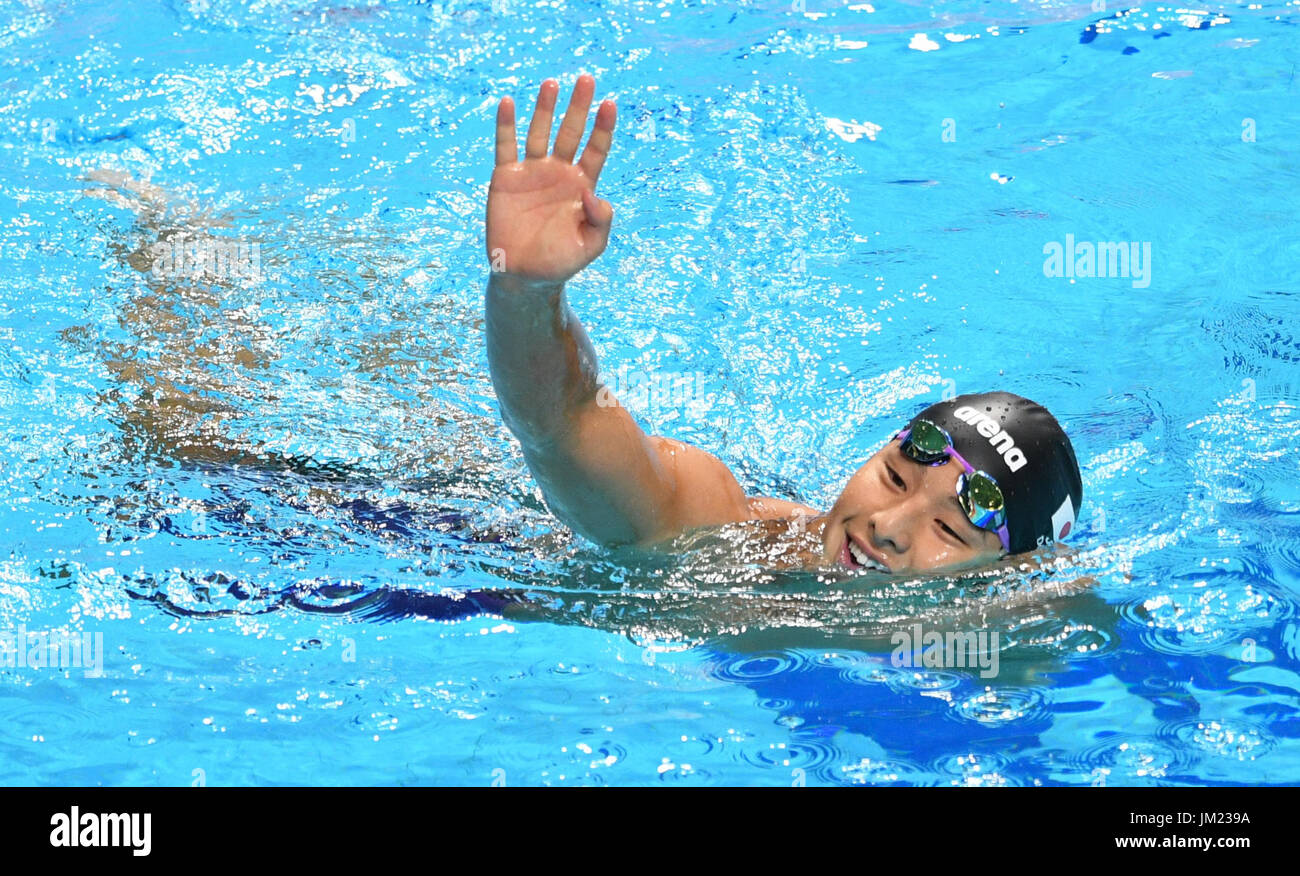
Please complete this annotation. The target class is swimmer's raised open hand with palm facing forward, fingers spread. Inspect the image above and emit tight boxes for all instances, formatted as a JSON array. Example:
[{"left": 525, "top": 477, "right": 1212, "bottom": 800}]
[{"left": 488, "top": 73, "right": 618, "bottom": 283}]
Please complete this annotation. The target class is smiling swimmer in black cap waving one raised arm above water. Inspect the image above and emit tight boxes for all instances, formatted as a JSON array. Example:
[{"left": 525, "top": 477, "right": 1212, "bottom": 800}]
[{"left": 486, "top": 74, "right": 1083, "bottom": 574}]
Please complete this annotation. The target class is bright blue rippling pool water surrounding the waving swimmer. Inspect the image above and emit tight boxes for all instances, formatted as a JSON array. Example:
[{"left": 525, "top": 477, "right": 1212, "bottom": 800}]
[{"left": 0, "top": 0, "right": 1300, "bottom": 785}]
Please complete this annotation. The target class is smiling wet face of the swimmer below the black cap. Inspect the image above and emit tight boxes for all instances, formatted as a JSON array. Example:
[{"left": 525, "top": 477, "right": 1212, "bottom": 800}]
[{"left": 822, "top": 438, "right": 1002, "bottom": 573}]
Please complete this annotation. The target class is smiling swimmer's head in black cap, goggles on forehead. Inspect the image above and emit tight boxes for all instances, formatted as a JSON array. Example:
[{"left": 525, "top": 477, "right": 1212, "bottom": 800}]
[{"left": 822, "top": 393, "right": 1083, "bottom": 573}]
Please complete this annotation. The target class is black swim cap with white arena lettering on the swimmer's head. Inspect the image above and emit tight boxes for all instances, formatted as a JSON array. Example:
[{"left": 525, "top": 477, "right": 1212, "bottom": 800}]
[{"left": 909, "top": 393, "right": 1083, "bottom": 554}]
